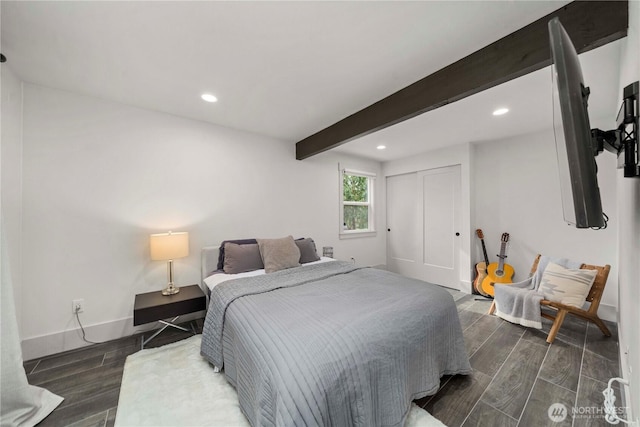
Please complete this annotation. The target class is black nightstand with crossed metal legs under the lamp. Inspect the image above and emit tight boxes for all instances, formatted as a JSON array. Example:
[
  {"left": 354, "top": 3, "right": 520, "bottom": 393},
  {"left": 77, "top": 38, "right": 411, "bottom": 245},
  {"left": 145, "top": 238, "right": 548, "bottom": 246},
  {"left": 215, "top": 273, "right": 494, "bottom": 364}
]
[{"left": 133, "top": 285, "right": 207, "bottom": 348}]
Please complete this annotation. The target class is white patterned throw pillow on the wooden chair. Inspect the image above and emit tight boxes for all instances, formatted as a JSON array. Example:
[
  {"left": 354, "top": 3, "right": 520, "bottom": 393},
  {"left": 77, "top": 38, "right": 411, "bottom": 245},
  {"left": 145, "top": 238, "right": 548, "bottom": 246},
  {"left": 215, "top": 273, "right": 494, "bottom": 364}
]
[{"left": 538, "top": 262, "right": 598, "bottom": 308}]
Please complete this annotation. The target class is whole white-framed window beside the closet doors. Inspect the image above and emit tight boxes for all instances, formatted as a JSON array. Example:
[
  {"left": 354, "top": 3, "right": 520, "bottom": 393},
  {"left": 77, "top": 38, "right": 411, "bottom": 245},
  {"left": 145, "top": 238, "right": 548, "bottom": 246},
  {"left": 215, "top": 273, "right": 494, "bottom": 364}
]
[{"left": 340, "top": 169, "right": 375, "bottom": 237}]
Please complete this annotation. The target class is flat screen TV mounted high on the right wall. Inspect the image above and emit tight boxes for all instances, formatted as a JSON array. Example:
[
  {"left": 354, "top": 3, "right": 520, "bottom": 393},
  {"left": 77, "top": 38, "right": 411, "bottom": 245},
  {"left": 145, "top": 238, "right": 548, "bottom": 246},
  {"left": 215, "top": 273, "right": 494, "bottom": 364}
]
[{"left": 548, "top": 18, "right": 606, "bottom": 228}]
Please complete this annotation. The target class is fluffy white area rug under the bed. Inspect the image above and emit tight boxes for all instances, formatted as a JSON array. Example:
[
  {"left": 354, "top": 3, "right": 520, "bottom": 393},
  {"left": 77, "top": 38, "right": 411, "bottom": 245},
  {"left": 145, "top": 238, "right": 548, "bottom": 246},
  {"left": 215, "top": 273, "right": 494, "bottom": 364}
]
[{"left": 115, "top": 335, "right": 446, "bottom": 427}]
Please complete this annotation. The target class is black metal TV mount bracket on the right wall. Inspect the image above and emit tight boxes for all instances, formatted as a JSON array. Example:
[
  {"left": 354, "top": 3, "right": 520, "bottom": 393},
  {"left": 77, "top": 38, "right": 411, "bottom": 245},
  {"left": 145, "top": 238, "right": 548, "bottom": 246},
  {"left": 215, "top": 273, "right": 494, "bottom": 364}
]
[{"left": 591, "top": 82, "right": 640, "bottom": 178}]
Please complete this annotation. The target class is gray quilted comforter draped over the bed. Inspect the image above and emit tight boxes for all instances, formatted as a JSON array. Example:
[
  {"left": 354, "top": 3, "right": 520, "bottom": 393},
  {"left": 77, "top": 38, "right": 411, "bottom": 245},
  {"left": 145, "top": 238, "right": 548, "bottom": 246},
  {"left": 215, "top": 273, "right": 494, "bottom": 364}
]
[{"left": 201, "top": 262, "right": 471, "bottom": 427}]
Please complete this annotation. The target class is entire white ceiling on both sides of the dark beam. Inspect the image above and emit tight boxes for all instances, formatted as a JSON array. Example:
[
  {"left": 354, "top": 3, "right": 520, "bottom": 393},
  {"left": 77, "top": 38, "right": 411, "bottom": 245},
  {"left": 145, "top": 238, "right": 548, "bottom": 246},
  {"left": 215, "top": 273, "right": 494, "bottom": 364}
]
[{"left": 0, "top": 0, "right": 620, "bottom": 161}]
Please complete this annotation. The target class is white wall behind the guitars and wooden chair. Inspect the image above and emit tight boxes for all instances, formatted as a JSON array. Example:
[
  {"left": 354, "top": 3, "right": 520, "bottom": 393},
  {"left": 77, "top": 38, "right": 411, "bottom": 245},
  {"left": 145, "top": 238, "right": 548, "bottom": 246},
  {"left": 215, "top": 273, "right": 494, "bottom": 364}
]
[{"left": 473, "top": 130, "right": 619, "bottom": 321}]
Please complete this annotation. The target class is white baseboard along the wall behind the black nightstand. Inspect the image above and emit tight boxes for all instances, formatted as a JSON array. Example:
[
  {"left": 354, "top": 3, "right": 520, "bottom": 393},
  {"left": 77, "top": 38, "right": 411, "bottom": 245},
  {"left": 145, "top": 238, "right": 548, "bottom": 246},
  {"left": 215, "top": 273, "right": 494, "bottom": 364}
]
[{"left": 22, "top": 311, "right": 205, "bottom": 360}]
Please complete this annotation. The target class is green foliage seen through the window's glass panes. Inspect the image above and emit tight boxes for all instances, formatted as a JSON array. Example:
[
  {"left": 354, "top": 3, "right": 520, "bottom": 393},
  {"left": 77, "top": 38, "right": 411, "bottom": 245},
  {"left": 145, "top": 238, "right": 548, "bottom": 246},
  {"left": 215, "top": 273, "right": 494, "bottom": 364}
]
[{"left": 342, "top": 174, "right": 369, "bottom": 230}]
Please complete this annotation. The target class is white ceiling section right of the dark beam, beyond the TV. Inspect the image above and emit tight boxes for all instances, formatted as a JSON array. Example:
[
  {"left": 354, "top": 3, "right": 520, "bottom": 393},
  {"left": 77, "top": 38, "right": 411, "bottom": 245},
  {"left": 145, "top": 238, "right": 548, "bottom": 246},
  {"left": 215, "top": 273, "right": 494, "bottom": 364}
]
[{"left": 334, "top": 40, "right": 622, "bottom": 161}]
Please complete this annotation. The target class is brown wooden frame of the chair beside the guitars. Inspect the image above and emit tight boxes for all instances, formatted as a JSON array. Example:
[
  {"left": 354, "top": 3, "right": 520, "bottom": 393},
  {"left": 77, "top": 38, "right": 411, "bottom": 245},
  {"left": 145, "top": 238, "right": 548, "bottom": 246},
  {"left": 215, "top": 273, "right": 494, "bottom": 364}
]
[{"left": 489, "top": 254, "right": 611, "bottom": 344}]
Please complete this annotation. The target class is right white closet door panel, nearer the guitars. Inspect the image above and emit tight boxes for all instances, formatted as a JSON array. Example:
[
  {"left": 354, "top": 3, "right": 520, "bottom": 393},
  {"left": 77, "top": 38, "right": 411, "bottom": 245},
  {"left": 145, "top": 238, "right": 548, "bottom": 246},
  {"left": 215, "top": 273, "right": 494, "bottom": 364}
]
[{"left": 418, "top": 165, "right": 461, "bottom": 289}]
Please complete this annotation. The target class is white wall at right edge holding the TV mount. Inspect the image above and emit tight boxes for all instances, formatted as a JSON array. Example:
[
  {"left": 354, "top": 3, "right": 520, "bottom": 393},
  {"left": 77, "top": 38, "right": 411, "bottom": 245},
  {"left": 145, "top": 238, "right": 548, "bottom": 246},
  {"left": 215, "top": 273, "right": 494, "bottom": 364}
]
[{"left": 617, "top": 1, "right": 640, "bottom": 424}]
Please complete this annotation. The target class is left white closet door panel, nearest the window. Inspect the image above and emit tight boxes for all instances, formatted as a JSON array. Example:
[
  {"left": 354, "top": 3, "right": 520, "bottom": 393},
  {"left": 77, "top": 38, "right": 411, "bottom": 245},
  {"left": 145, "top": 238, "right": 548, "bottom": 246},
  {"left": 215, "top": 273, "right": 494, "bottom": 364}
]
[{"left": 387, "top": 172, "right": 421, "bottom": 278}]
